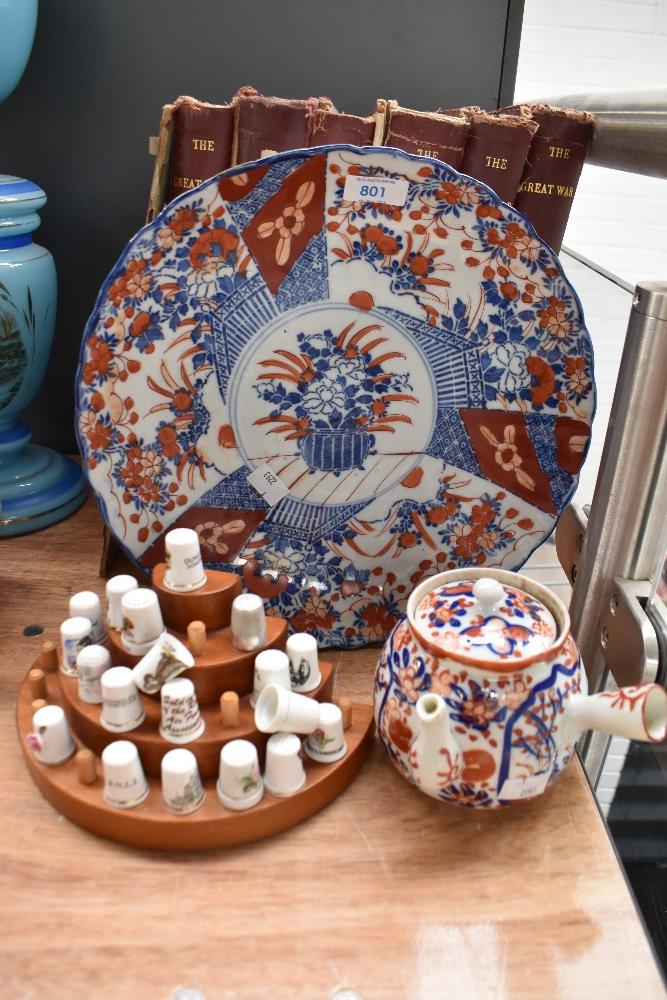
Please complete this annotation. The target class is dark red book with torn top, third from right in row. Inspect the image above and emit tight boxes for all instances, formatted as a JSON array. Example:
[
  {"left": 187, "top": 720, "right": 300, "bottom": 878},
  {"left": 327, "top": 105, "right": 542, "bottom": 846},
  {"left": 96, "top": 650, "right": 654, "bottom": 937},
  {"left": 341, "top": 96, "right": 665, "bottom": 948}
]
[{"left": 383, "top": 101, "right": 470, "bottom": 170}]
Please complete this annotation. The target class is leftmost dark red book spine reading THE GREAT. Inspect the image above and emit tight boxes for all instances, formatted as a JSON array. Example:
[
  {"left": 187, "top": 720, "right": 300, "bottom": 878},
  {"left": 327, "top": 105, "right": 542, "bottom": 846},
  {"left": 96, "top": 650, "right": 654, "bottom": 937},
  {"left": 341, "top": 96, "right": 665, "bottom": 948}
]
[{"left": 167, "top": 99, "right": 234, "bottom": 201}]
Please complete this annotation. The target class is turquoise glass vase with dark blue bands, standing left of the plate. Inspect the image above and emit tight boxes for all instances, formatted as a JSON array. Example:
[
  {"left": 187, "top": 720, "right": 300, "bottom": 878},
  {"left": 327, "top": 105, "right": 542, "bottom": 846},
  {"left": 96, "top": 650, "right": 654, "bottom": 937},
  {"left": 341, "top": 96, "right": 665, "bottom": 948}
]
[{"left": 0, "top": 180, "right": 86, "bottom": 538}]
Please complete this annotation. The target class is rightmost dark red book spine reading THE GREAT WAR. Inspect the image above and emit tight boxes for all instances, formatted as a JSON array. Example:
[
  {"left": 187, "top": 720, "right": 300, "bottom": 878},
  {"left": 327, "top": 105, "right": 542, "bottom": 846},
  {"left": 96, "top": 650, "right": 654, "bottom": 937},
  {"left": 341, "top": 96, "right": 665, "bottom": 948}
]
[{"left": 512, "top": 105, "right": 594, "bottom": 253}]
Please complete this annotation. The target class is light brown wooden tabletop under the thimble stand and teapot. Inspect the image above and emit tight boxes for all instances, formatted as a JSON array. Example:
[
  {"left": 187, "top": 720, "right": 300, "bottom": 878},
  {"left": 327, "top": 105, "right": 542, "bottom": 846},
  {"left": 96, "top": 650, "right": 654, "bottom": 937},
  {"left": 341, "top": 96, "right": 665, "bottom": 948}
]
[{"left": 0, "top": 501, "right": 664, "bottom": 1000}]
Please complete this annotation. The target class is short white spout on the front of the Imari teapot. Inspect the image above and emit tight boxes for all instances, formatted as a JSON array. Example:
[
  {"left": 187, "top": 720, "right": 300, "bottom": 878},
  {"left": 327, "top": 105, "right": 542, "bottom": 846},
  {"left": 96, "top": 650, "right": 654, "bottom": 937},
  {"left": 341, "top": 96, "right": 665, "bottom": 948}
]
[{"left": 412, "top": 694, "right": 463, "bottom": 796}]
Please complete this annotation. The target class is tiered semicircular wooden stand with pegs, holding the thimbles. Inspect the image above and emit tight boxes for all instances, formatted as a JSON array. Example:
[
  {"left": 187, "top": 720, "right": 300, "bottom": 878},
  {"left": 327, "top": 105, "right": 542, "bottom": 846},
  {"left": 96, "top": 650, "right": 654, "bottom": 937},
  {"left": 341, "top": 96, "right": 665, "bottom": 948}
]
[{"left": 17, "top": 564, "right": 373, "bottom": 851}]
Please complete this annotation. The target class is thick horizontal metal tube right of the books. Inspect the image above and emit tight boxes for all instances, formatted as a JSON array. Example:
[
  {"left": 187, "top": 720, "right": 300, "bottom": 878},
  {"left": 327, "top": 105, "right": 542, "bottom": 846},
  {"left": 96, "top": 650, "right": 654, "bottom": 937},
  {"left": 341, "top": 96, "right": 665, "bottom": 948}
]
[{"left": 525, "top": 87, "right": 667, "bottom": 177}]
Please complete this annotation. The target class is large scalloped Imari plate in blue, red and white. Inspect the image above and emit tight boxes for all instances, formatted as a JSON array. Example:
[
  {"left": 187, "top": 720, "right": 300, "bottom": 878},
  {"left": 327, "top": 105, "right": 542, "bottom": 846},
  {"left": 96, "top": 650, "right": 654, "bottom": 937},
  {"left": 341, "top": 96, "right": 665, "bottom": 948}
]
[{"left": 77, "top": 146, "right": 594, "bottom": 646}]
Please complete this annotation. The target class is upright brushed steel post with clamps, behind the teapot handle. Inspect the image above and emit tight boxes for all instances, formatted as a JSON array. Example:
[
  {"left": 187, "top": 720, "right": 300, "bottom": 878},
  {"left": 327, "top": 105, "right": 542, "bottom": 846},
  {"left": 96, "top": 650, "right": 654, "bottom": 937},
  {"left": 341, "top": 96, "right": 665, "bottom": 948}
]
[{"left": 557, "top": 282, "right": 667, "bottom": 691}]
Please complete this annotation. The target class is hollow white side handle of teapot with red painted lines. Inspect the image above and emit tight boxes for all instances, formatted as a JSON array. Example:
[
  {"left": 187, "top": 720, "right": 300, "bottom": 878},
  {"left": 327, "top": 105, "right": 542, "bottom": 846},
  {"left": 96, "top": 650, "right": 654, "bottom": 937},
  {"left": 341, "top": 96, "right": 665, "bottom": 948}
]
[{"left": 565, "top": 684, "right": 667, "bottom": 743}]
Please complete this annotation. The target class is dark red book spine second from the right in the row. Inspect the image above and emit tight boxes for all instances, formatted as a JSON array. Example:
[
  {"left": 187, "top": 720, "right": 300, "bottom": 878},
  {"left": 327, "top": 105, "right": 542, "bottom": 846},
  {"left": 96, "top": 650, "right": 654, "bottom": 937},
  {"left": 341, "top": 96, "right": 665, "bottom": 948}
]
[{"left": 461, "top": 110, "right": 537, "bottom": 204}]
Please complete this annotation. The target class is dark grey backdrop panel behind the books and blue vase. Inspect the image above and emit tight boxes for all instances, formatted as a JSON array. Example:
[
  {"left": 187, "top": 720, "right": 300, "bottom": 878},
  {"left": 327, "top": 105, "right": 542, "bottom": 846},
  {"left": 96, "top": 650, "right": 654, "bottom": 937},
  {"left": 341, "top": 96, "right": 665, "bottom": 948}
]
[{"left": 0, "top": 0, "right": 523, "bottom": 451}]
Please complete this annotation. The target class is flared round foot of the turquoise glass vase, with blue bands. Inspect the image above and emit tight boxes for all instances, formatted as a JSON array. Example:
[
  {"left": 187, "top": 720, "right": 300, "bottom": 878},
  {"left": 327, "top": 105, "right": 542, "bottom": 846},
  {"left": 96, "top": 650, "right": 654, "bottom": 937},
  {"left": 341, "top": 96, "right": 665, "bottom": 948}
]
[{"left": 0, "top": 423, "right": 87, "bottom": 538}]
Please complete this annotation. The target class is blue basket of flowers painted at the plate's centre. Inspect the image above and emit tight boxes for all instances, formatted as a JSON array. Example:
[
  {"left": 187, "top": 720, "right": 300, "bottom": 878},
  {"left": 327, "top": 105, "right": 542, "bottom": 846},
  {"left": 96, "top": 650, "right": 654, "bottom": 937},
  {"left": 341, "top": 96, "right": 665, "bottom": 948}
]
[{"left": 255, "top": 323, "right": 417, "bottom": 474}]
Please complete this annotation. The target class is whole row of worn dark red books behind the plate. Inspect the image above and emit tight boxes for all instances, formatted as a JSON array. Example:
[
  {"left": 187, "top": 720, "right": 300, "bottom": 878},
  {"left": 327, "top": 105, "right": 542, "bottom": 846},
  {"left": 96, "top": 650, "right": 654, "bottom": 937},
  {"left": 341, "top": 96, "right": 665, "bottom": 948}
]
[{"left": 148, "top": 87, "right": 594, "bottom": 252}]
